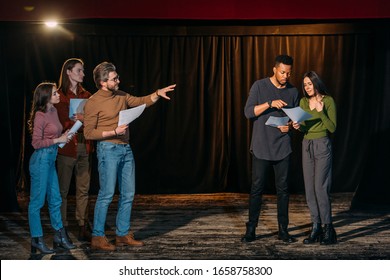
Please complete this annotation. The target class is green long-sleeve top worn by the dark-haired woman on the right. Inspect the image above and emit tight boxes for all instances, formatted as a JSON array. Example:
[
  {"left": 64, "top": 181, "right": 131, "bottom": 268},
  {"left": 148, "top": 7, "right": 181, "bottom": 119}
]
[{"left": 299, "top": 95, "right": 336, "bottom": 139}]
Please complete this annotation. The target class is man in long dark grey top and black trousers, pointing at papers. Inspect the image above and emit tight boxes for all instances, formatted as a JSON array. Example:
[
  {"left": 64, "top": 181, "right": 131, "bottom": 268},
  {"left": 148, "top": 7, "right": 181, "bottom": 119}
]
[{"left": 241, "top": 55, "right": 299, "bottom": 243}]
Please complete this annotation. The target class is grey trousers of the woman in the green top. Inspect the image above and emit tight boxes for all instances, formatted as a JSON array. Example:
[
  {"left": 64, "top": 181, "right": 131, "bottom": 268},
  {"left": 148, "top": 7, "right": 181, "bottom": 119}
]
[{"left": 302, "top": 137, "right": 332, "bottom": 224}]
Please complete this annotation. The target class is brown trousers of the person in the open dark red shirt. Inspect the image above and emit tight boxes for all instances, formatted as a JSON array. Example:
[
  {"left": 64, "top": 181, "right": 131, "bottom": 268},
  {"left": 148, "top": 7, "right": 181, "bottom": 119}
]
[{"left": 57, "top": 143, "right": 91, "bottom": 226}]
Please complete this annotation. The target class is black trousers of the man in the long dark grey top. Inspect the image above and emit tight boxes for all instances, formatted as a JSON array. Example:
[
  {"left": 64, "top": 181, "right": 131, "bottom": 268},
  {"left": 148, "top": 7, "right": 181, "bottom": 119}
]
[{"left": 249, "top": 156, "right": 290, "bottom": 229}]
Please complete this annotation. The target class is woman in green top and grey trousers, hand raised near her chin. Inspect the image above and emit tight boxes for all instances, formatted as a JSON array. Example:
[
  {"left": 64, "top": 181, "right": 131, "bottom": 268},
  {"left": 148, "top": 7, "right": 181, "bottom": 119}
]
[{"left": 293, "top": 71, "right": 337, "bottom": 245}]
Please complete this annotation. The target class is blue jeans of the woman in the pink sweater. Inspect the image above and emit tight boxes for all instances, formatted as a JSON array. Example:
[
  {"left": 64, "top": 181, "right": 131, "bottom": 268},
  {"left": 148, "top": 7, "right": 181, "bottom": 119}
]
[{"left": 28, "top": 145, "right": 62, "bottom": 237}]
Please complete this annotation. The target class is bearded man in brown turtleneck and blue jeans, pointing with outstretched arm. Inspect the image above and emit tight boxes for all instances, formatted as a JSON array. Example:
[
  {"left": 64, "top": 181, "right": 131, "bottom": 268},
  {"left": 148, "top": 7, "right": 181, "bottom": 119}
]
[{"left": 84, "top": 62, "right": 176, "bottom": 251}]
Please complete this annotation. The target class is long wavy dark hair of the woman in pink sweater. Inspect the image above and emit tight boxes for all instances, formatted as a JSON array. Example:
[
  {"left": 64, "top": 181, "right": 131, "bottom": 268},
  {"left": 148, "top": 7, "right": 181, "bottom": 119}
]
[{"left": 27, "top": 82, "right": 57, "bottom": 135}]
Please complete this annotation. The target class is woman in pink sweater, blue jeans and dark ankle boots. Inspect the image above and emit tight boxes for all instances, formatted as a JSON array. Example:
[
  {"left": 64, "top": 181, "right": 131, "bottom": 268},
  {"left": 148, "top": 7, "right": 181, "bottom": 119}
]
[{"left": 28, "top": 83, "right": 76, "bottom": 254}]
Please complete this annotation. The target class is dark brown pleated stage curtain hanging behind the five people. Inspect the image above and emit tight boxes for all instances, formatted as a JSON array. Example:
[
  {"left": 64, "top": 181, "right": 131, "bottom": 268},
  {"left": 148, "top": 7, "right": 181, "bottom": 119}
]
[{"left": 0, "top": 20, "right": 390, "bottom": 211}]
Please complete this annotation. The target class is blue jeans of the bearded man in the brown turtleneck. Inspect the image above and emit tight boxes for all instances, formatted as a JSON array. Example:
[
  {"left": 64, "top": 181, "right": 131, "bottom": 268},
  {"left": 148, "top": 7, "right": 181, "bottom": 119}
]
[{"left": 92, "top": 141, "right": 135, "bottom": 236}]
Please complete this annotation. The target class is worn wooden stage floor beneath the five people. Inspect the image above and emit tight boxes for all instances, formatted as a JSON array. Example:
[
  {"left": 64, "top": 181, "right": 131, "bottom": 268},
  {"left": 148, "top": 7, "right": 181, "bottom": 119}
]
[{"left": 0, "top": 193, "right": 390, "bottom": 260}]
